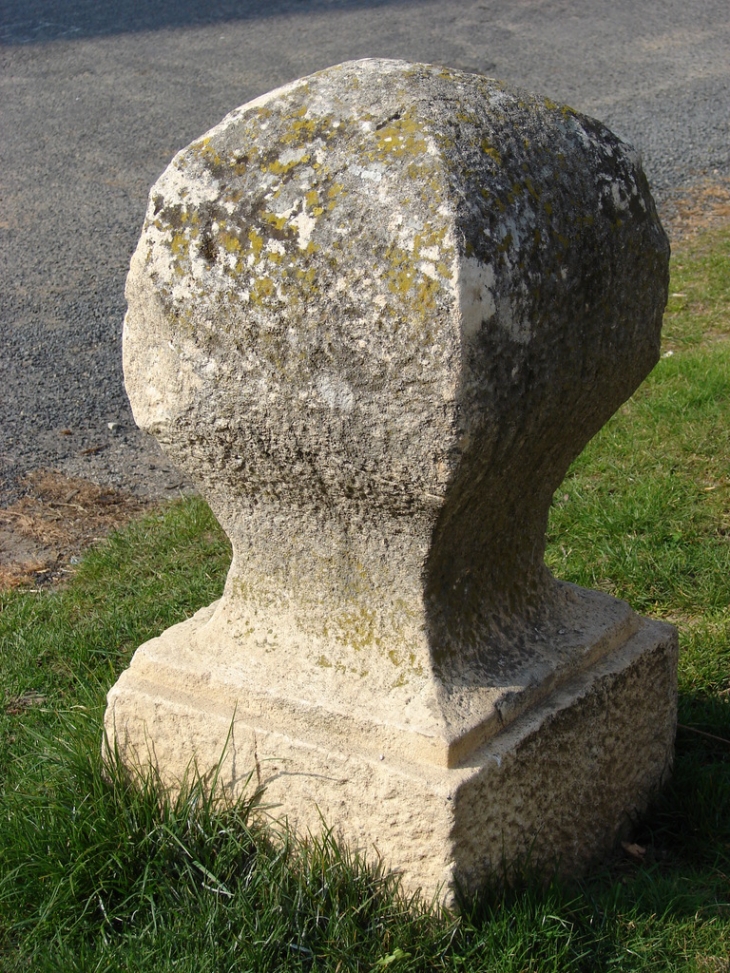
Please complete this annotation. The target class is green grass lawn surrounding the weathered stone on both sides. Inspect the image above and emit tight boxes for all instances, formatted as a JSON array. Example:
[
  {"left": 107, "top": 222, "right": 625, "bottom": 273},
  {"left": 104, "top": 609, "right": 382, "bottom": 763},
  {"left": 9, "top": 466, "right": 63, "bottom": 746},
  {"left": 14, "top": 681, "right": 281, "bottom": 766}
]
[{"left": 0, "top": 224, "right": 730, "bottom": 973}]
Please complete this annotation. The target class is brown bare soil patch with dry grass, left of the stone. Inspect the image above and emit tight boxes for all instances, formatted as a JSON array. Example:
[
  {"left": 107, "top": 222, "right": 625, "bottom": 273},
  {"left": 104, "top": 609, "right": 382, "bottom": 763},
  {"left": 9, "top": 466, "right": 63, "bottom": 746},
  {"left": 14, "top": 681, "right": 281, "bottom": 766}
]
[{"left": 0, "top": 471, "right": 149, "bottom": 589}]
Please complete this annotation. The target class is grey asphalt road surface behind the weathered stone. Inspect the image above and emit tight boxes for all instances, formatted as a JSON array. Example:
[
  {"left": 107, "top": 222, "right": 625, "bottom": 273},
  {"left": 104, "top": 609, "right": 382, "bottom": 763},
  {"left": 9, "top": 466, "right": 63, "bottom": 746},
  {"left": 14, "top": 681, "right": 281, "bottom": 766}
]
[{"left": 0, "top": 0, "right": 730, "bottom": 503}]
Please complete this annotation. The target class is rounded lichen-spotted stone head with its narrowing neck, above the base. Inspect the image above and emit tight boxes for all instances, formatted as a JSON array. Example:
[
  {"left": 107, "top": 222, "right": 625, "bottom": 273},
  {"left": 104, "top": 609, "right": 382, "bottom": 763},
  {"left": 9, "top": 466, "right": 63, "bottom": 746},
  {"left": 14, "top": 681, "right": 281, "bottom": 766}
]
[{"left": 124, "top": 60, "right": 669, "bottom": 660}]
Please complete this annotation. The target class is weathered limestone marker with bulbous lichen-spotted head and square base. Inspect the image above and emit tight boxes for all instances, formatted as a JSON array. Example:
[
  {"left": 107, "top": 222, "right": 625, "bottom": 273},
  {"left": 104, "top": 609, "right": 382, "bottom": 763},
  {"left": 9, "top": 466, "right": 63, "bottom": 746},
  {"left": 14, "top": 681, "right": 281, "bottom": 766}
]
[{"left": 106, "top": 60, "right": 677, "bottom": 899}]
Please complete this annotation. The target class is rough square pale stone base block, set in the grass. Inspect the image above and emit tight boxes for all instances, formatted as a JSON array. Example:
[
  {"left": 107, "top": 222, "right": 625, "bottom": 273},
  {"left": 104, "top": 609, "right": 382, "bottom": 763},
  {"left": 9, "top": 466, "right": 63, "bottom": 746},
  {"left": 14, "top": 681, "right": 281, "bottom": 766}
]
[{"left": 105, "top": 608, "right": 677, "bottom": 901}]
